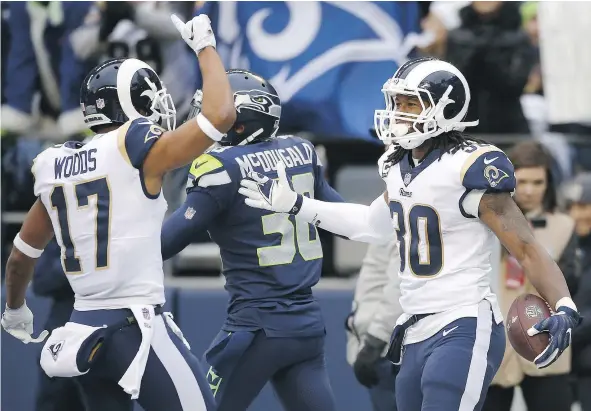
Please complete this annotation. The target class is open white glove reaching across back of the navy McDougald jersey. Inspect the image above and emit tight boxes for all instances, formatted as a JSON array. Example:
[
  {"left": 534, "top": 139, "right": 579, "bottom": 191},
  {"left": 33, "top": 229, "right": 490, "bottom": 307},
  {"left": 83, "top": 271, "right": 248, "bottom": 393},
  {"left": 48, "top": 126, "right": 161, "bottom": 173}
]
[{"left": 238, "top": 161, "right": 303, "bottom": 214}]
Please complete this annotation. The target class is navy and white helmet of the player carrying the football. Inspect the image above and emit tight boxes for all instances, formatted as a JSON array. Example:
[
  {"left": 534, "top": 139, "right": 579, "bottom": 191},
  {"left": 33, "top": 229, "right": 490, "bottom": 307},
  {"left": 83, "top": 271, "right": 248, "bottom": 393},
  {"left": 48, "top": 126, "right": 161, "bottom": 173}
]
[{"left": 374, "top": 58, "right": 478, "bottom": 150}]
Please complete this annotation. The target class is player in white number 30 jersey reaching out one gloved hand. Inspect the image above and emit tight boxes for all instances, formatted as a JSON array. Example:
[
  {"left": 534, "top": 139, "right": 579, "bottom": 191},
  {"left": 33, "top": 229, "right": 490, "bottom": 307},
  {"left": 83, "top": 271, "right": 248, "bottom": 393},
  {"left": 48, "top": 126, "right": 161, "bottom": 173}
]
[{"left": 240, "top": 58, "right": 581, "bottom": 411}]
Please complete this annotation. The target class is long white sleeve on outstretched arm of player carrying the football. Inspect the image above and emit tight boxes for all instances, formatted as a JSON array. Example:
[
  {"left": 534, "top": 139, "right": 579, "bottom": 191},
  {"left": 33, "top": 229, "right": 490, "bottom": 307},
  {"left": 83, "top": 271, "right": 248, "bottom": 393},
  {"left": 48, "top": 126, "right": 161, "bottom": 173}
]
[{"left": 298, "top": 195, "right": 395, "bottom": 244}]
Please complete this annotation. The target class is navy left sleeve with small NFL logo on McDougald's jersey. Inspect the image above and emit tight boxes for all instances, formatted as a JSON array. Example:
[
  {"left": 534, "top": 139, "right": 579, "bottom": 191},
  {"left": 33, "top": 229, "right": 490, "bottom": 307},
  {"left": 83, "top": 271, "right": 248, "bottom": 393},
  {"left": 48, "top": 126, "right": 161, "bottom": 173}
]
[{"left": 160, "top": 190, "right": 220, "bottom": 260}]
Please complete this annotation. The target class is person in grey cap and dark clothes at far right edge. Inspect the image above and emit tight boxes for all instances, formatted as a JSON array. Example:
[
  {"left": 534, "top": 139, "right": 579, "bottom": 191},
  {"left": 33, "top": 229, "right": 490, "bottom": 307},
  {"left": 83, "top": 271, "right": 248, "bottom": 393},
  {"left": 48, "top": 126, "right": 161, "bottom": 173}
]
[{"left": 563, "top": 172, "right": 591, "bottom": 411}]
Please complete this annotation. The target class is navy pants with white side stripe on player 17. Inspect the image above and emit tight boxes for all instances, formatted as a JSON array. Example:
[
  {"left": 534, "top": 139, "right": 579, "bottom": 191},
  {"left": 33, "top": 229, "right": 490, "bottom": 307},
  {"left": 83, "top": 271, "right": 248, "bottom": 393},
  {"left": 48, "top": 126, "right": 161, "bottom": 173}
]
[{"left": 71, "top": 310, "right": 215, "bottom": 411}]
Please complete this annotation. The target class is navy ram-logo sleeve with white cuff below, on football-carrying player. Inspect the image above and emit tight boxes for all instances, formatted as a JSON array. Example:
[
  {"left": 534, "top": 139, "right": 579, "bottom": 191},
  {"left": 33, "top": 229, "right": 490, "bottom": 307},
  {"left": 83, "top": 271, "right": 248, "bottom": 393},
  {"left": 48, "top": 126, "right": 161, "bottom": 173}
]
[{"left": 459, "top": 146, "right": 516, "bottom": 218}]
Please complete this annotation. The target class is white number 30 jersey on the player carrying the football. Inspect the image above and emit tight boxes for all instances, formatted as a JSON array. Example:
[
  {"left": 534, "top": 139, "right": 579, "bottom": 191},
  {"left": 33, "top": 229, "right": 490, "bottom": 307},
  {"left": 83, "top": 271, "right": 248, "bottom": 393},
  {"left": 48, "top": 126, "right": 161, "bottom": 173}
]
[{"left": 379, "top": 144, "right": 515, "bottom": 343}]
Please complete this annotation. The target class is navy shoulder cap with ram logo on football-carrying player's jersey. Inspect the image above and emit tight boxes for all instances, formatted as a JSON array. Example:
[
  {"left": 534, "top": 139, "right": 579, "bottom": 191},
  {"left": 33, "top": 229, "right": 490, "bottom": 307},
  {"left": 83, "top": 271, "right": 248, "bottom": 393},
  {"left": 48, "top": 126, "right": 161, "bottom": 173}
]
[{"left": 460, "top": 145, "right": 516, "bottom": 192}]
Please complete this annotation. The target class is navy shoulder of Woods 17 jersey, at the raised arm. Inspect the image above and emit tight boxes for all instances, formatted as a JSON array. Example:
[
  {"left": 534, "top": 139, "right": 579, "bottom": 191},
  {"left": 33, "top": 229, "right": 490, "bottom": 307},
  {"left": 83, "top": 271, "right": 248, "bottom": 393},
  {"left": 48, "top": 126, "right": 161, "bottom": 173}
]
[{"left": 117, "top": 118, "right": 166, "bottom": 169}]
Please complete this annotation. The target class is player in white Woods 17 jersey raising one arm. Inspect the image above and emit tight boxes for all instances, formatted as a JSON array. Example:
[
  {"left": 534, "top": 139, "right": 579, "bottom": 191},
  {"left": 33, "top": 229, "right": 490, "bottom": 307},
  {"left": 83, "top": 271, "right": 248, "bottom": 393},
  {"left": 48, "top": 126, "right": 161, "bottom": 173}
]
[{"left": 2, "top": 15, "right": 236, "bottom": 411}]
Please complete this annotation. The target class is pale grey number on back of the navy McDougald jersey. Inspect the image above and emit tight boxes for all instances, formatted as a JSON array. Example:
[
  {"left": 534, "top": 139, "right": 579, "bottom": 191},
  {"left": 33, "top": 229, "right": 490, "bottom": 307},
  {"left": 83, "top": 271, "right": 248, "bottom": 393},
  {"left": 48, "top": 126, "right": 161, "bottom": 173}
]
[{"left": 257, "top": 173, "right": 322, "bottom": 267}]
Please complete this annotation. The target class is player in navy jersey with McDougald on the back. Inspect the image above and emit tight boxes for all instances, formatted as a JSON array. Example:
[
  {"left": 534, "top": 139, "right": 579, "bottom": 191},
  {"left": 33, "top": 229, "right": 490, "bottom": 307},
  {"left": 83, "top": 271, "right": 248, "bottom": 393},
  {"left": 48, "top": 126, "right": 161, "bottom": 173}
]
[{"left": 162, "top": 70, "right": 343, "bottom": 411}]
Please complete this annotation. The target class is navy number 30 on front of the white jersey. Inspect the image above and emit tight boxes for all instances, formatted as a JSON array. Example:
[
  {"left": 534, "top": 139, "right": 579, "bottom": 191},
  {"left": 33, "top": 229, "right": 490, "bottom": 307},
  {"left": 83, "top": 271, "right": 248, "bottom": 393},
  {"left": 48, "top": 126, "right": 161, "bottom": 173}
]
[{"left": 390, "top": 201, "right": 443, "bottom": 277}]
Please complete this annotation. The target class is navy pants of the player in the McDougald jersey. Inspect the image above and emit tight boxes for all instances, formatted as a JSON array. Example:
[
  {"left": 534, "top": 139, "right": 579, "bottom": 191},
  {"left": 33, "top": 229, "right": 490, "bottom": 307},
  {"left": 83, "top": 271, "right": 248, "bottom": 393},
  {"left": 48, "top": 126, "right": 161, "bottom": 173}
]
[{"left": 203, "top": 331, "right": 335, "bottom": 411}]
